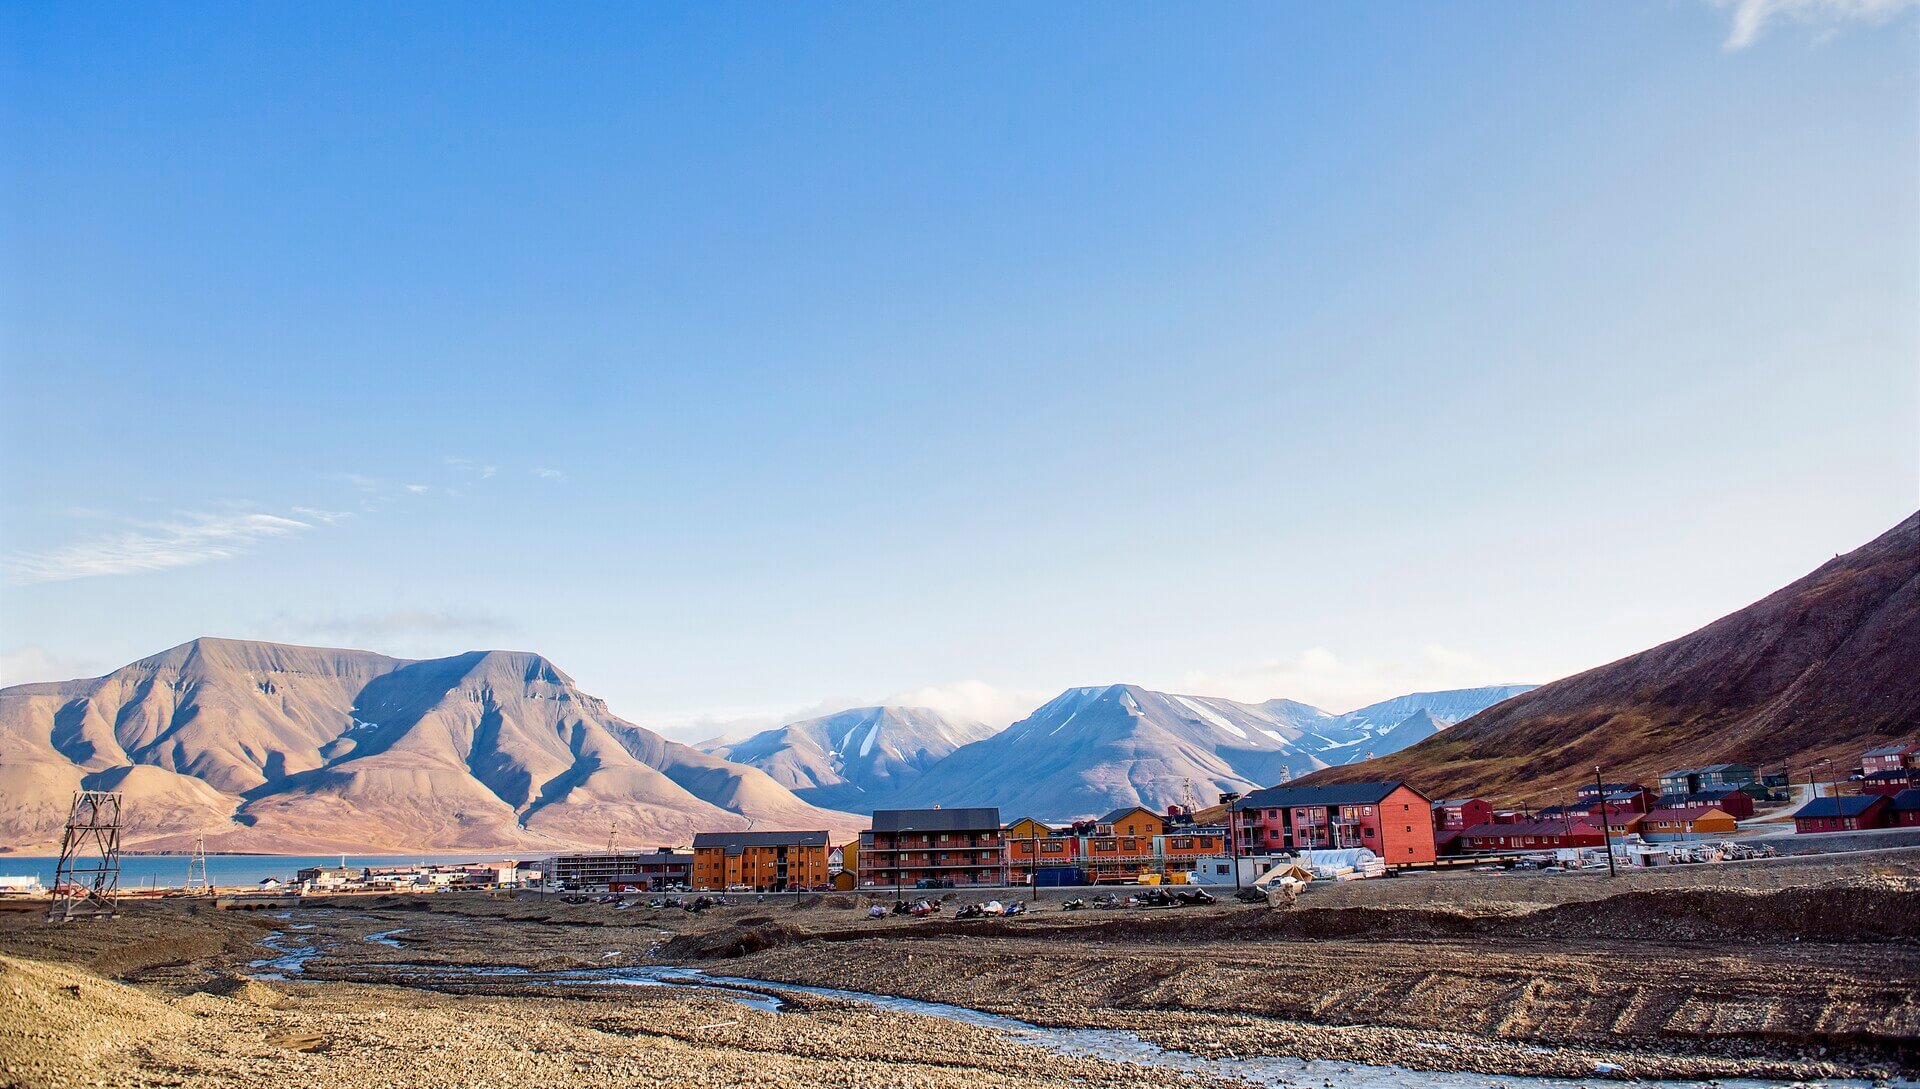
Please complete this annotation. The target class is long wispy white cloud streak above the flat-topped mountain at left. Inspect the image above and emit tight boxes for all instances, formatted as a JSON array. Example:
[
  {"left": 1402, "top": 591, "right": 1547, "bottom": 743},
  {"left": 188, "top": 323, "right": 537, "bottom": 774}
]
[{"left": 0, "top": 513, "right": 313, "bottom": 582}]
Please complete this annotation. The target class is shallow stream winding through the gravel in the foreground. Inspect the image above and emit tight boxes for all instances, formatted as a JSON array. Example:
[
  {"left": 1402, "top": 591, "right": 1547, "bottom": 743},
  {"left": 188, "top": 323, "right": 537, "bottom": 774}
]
[{"left": 252, "top": 932, "right": 1920, "bottom": 1089}]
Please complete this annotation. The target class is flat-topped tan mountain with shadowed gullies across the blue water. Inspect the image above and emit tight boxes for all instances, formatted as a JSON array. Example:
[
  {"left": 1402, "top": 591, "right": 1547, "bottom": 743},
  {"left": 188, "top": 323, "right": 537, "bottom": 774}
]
[{"left": 0, "top": 640, "right": 862, "bottom": 853}]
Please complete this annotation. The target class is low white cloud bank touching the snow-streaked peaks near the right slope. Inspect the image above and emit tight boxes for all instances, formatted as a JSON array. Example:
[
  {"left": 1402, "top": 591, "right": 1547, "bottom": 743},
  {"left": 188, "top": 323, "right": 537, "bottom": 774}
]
[{"left": 1181, "top": 643, "right": 1551, "bottom": 714}]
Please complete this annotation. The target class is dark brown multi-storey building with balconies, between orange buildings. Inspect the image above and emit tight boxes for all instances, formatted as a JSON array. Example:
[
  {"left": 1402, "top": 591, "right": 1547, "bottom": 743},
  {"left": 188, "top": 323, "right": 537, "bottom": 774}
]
[{"left": 860, "top": 807, "right": 1006, "bottom": 889}]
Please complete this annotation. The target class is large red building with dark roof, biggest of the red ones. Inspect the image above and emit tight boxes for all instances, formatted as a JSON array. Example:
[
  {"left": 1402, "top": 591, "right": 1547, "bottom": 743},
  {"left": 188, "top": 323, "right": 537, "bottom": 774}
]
[{"left": 1229, "top": 780, "right": 1434, "bottom": 866}]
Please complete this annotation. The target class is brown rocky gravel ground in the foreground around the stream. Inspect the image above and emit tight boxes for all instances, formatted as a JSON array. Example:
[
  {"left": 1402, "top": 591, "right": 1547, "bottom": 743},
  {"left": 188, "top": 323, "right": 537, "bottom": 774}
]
[{"left": 0, "top": 853, "right": 1920, "bottom": 1087}]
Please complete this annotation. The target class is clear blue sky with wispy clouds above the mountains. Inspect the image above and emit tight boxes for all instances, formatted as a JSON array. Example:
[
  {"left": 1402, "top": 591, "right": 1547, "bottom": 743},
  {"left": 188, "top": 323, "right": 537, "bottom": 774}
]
[{"left": 0, "top": 0, "right": 1920, "bottom": 738}]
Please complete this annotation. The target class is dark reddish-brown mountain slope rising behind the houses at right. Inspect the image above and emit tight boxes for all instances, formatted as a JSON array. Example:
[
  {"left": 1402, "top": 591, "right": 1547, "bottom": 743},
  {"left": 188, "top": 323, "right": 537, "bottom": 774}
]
[{"left": 1302, "top": 515, "right": 1920, "bottom": 803}]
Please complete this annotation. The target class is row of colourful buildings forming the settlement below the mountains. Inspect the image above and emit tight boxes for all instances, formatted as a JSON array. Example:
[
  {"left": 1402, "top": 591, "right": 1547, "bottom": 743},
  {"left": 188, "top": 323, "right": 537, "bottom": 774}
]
[{"left": 45, "top": 743, "right": 1920, "bottom": 897}]
